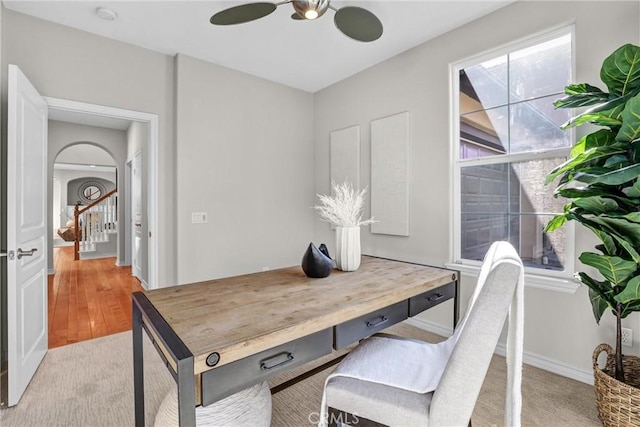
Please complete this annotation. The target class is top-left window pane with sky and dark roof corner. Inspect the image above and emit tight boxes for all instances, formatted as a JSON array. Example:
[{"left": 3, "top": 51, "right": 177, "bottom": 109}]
[{"left": 460, "top": 56, "right": 509, "bottom": 113}]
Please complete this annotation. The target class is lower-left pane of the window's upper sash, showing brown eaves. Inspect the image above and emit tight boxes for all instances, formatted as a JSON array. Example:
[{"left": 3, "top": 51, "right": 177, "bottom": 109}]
[{"left": 460, "top": 107, "right": 509, "bottom": 159}]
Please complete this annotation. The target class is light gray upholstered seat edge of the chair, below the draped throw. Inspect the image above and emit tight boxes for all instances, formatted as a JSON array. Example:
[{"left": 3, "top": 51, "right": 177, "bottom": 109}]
[{"left": 326, "top": 377, "right": 433, "bottom": 427}]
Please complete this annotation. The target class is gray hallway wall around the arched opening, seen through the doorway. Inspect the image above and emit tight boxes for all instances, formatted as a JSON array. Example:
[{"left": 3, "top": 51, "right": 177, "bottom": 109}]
[{"left": 47, "top": 121, "right": 127, "bottom": 271}]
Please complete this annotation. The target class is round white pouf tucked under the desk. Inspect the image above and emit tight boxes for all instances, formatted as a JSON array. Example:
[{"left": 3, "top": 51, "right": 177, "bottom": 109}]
[{"left": 154, "top": 381, "right": 271, "bottom": 427}]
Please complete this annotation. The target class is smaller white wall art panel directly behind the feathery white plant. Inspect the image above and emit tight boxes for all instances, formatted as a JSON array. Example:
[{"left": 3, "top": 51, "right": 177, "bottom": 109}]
[{"left": 330, "top": 126, "right": 360, "bottom": 189}]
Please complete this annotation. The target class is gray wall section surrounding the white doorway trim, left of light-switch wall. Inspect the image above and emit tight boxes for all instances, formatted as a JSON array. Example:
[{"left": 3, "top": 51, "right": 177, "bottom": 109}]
[{"left": 2, "top": 9, "right": 177, "bottom": 286}]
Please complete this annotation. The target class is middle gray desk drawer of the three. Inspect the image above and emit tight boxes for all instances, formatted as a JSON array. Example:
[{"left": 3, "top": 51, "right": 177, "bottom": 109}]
[{"left": 333, "top": 300, "right": 408, "bottom": 350}]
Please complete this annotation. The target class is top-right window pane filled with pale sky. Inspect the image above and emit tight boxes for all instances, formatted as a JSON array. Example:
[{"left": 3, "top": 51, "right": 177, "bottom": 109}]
[{"left": 509, "top": 34, "right": 571, "bottom": 102}]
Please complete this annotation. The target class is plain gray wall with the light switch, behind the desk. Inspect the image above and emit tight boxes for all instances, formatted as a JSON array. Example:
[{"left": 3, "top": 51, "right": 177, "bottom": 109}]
[{"left": 176, "top": 55, "right": 314, "bottom": 283}]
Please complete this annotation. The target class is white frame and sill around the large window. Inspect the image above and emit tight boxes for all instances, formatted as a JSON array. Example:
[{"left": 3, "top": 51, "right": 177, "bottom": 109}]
[{"left": 446, "top": 25, "right": 580, "bottom": 293}]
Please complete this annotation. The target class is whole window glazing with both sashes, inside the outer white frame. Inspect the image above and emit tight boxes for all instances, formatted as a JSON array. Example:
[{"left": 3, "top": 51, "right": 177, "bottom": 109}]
[{"left": 453, "top": 29, "right": 573, "bottom": 277}]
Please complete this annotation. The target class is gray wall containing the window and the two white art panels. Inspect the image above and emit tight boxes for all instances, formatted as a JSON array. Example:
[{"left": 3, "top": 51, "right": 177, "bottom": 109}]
[{"left": 314, "top": 1, "right": 640, "bottom": 379}]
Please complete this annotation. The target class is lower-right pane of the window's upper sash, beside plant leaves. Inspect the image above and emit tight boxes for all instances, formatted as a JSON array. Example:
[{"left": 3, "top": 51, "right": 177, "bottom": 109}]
[{"left": 509, "top": 95, "right": 571, "bottom": 153}]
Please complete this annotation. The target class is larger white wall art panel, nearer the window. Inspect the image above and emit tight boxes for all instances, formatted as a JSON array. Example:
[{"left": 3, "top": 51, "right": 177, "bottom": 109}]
[{"left": 371, "top": 112, "right": 409, "bottom": 236}]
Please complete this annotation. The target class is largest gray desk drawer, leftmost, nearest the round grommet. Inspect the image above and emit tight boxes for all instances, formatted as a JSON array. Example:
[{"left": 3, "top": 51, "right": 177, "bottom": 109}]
[{"left": 202, "top": 328, "right": 333, "bottom": 406}]
